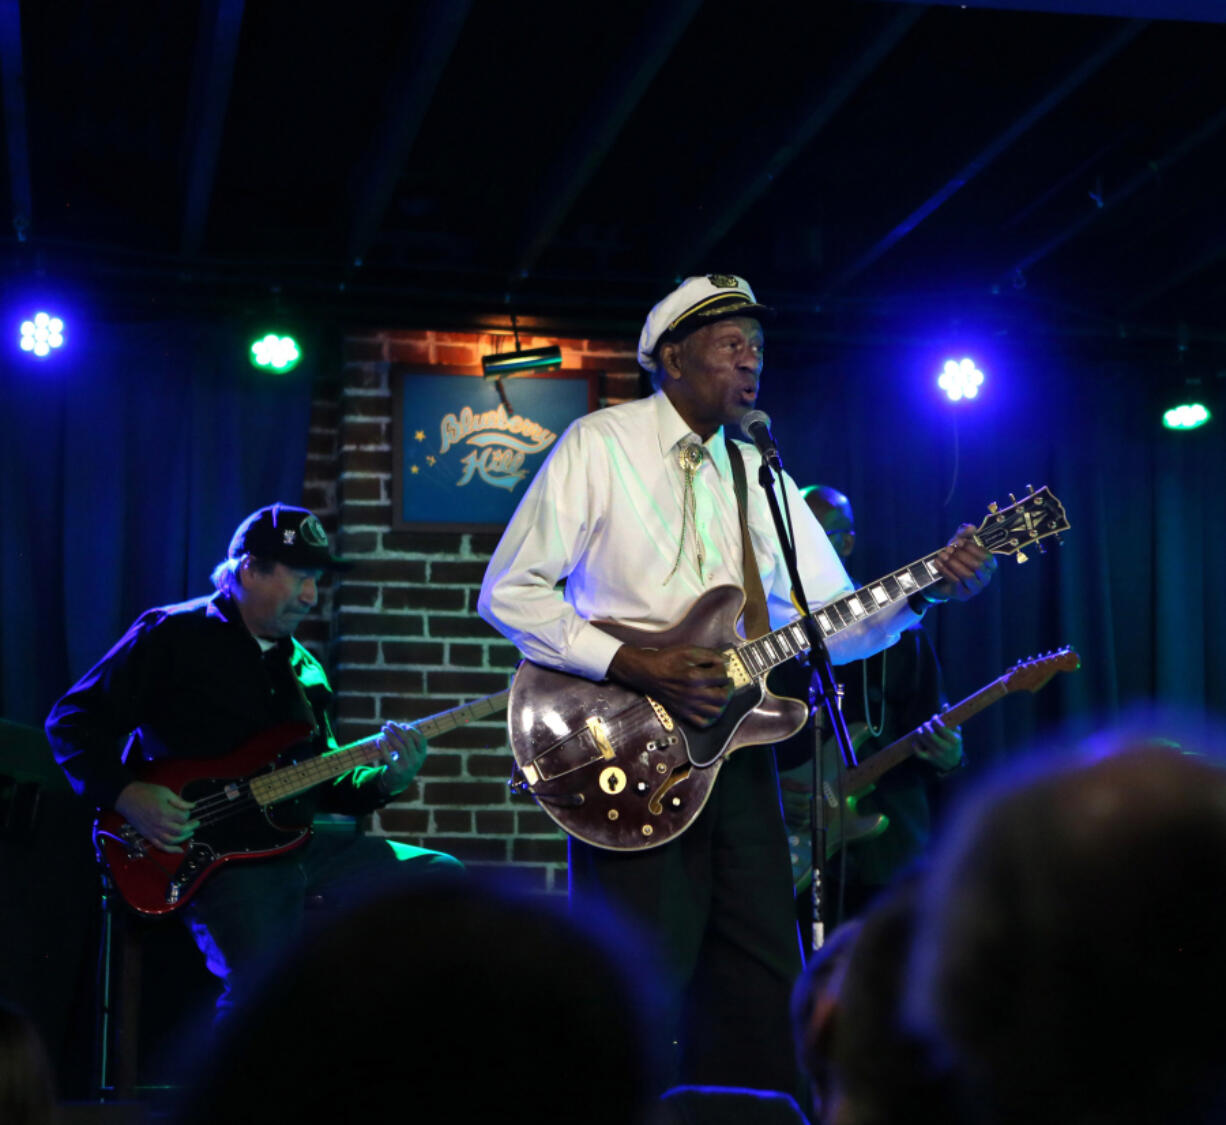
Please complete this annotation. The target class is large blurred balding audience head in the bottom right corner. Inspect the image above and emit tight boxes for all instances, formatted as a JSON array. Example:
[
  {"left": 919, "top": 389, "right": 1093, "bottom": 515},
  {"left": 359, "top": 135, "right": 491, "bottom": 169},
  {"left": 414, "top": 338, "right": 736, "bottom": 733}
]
[{"left": 912, "top": 734, "right": 1226, "bottom": 1125}]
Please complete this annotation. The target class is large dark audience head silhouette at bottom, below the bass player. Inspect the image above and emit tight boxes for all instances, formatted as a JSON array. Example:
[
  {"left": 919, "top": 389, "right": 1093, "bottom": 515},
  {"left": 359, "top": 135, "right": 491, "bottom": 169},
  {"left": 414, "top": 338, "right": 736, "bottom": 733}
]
[{"left": 174, "top": 879, "right": 666, "bottom": 1125}]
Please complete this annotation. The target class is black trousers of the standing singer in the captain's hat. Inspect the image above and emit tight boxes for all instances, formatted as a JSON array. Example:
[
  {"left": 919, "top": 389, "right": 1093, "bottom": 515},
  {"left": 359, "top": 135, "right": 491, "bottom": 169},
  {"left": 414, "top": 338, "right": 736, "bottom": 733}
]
[{"left": 570, "top": 746, "right": 801, "bottom": 1096}]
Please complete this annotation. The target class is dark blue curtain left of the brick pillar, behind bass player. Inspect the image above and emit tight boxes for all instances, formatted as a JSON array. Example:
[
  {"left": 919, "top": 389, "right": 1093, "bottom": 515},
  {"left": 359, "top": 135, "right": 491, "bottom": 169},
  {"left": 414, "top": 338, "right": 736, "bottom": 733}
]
[{"left": 0, "top": 321, "right": 311, "bottom": 724}]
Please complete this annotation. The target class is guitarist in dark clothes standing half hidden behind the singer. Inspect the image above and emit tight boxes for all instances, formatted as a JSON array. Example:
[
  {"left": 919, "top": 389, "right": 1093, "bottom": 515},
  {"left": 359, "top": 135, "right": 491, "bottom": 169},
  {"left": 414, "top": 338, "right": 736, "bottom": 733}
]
[{"left": 771, "top": 485, "right": 962, "bottom": 923}]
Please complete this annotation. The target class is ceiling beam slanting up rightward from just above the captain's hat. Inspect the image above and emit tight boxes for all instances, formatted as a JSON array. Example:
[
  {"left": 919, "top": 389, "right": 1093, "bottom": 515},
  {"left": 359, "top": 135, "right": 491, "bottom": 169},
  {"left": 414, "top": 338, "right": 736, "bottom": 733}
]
[{"left": 661, "top": 7, "right": 923, "bottom": 277}]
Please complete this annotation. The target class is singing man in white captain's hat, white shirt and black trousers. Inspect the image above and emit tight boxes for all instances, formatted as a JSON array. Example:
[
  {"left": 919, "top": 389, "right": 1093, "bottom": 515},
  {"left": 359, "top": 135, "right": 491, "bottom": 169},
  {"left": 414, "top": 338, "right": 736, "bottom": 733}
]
[{"left": 478, "top": 273, "right": 994, "bottom": 1107}]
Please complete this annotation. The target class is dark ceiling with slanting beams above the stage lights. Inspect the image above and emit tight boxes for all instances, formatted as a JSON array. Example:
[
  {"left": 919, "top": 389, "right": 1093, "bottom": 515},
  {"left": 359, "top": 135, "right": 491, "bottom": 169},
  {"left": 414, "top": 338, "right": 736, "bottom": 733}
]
[{"left": 0, "top": 0, "right": 1226, "bottom": 352}]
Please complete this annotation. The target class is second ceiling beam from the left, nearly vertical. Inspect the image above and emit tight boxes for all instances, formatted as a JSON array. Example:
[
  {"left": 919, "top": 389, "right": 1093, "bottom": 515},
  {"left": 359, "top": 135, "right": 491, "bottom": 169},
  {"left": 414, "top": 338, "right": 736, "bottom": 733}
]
[{"left": 179, "top": 0, "right": 244, "bottom": 259}]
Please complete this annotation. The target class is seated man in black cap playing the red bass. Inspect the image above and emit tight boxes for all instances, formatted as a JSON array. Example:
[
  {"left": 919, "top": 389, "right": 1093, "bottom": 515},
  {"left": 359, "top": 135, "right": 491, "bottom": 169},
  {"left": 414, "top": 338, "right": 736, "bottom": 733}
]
[{"left": 47, "top": 504, "right": 459, "bottom": 1010}]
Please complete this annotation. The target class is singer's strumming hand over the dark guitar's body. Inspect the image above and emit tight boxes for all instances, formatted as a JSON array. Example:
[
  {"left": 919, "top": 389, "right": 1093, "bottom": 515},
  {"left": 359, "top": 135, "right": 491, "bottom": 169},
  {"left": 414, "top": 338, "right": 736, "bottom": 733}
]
[{"left": 608, "top": 645, "right": 732, "bottom": 727}]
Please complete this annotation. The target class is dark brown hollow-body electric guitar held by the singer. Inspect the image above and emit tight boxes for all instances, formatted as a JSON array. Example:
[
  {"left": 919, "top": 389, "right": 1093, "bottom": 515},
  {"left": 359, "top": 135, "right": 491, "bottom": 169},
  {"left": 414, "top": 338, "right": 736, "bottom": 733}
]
[{"left": 506, "top": 488, "right": 1069, "bottom": 850}]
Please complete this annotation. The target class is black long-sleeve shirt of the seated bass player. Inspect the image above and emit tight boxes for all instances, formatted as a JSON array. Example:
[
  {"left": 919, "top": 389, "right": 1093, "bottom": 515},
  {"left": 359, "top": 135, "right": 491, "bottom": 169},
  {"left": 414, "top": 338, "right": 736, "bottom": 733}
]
[{"left": 47, "top": 594, "right": 384, "bottom": 815}]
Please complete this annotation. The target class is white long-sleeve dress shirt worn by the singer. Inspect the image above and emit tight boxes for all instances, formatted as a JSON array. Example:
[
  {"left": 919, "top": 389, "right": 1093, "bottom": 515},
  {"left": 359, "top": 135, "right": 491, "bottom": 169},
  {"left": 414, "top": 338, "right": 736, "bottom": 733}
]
[{"left": 477, "top": 392, "right": 916, "bottom": 680}]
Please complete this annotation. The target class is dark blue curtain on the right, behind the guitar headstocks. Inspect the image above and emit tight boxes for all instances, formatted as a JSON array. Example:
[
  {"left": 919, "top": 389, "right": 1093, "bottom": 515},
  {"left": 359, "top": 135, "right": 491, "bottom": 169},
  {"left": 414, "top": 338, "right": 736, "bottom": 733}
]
[{"left": 760, "top": 338, "right": 1226, "bottom": 762}]
